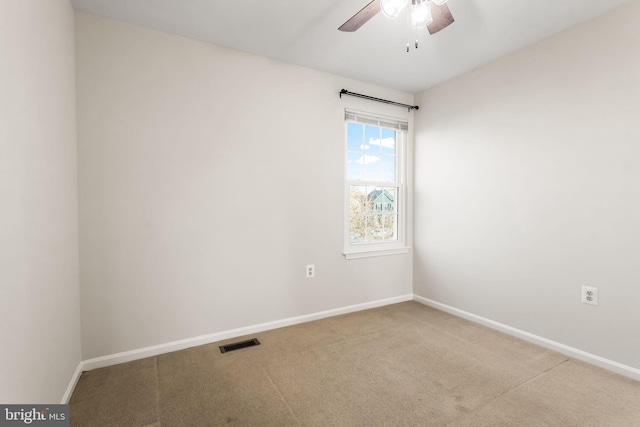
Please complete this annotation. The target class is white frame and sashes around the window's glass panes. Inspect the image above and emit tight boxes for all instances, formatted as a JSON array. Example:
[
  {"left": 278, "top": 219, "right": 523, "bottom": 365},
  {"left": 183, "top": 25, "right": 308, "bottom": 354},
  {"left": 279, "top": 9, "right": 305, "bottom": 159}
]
[{"left": 343, "top": 109, "right": 409, "bottom": 259}]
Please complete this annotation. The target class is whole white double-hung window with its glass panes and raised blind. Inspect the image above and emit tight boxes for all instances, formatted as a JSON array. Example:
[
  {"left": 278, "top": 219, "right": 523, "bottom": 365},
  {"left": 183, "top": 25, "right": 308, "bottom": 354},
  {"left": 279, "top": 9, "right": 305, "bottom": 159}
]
[{"left": 344, "top": 110, "right": 408, "bottom": 259}]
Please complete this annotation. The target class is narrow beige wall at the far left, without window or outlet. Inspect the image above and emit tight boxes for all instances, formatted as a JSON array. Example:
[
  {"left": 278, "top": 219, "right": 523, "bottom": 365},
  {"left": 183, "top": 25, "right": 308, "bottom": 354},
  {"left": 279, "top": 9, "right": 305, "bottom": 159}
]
[{"left": 0, "top": 0, "right": 80, "bottom": 403}]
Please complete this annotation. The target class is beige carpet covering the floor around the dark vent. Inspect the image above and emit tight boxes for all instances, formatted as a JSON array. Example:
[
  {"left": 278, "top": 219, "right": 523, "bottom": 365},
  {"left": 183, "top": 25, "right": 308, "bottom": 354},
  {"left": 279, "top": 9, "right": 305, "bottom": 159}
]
[{"left": 71, "top": 302, "right": 640, "bottom": 427}]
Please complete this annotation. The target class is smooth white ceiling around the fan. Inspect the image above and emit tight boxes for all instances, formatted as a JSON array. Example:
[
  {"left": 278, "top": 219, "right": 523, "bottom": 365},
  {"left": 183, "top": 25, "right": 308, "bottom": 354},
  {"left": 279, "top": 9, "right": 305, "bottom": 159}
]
[{"left": 72, "top": 0, "right": 632, "bottom": 93}]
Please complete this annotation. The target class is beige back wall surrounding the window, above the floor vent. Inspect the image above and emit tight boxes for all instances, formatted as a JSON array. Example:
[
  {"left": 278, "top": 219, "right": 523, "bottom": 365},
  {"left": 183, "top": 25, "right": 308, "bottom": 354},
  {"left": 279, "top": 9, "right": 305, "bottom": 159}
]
[{"left": 76, "top": 13, "right": 413, "bottom": 359}]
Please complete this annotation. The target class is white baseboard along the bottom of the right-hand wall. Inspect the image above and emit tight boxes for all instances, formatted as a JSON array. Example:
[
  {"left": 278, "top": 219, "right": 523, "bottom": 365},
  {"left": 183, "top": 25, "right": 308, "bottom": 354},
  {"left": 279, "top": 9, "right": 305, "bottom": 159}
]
[{"left": 413, "top": 294, "right": 640, "bottom": 381}]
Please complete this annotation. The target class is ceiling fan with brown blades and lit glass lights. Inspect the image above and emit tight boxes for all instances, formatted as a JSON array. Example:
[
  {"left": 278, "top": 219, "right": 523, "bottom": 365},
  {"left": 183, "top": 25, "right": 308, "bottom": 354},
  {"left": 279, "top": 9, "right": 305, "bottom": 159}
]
[{"left": 338, "top": 0, "right": 454, "bottom": 43}]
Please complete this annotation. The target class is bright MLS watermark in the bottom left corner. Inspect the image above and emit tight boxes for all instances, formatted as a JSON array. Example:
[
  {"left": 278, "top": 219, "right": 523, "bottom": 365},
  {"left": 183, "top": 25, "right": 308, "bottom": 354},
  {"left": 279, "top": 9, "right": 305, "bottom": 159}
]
[{"left": 0, "top": 405, "right": 69, "bottom": 427}]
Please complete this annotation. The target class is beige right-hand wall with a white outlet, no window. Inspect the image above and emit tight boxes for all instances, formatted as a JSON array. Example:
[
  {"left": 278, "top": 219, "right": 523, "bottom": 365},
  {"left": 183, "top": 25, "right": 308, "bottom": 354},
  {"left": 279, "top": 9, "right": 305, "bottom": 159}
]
[{"left": 414, "top": 2, "right": 640, "bottom": 369}]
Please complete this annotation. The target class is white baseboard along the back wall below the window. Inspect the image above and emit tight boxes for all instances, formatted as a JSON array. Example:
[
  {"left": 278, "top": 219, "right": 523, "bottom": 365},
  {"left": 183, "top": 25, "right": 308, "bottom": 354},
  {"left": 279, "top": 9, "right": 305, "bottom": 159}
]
[{"left": 82, "top": 294, "right": 414, "bottom": 372}]
